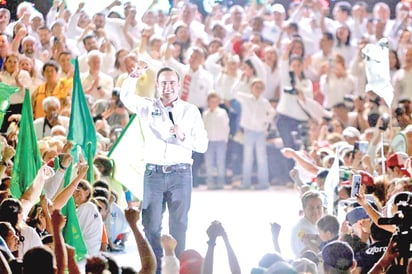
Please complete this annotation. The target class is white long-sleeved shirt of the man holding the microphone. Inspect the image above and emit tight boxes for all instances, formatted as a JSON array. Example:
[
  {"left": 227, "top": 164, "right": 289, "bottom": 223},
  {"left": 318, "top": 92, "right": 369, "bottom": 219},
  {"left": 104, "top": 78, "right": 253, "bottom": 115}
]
[{"left": 120, "top": 77, "right": 208, "bottom": 165}]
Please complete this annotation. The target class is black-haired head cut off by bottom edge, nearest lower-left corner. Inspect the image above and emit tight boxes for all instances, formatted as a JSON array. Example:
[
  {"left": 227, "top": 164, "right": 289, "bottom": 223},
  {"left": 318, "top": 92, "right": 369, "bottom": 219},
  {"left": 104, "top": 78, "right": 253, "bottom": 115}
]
[{"left": 23, "top": 246, "right": 54, "bottom": 274}]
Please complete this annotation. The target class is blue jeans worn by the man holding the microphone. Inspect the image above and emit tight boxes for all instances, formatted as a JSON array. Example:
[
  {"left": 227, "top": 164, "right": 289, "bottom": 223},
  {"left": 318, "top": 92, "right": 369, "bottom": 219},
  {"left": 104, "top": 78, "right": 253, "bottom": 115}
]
[{"left": 142, "top": 164, "right": 192, "bottom": 273}]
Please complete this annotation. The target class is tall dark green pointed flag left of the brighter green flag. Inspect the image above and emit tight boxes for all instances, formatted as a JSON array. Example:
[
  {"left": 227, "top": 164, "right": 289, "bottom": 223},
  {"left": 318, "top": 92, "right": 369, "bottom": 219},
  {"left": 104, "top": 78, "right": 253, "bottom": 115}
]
[{"left": 10, "top": 90, "right": 42, "bottom": 199}]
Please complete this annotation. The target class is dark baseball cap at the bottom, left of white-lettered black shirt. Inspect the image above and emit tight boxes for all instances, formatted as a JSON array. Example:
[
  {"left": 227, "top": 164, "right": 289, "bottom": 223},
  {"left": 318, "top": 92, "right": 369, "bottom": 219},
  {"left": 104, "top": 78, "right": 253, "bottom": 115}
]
[{"left": 322, "top": 241, "right": 354, "bottom": 271}]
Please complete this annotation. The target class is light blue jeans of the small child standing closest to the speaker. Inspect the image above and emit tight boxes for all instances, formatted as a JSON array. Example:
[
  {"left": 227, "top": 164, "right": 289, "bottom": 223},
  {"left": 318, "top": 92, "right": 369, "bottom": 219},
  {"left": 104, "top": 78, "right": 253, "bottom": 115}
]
[{"left": 205, "top": 141, "right": 227, "bottom": 187}]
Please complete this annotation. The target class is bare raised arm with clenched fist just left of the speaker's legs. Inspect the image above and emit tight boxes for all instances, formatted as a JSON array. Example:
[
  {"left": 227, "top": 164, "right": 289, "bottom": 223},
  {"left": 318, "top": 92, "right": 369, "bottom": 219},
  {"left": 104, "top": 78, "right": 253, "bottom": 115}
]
[{"left": 124, "top": 208, "right": 157, "bottom": 274}]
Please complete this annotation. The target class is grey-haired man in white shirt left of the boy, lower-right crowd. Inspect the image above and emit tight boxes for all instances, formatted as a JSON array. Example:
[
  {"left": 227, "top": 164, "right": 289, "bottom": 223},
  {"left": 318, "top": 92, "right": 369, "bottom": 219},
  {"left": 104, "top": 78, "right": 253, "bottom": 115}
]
[{"left": 291, "top": 191, "right": 323, "bottom": 257}]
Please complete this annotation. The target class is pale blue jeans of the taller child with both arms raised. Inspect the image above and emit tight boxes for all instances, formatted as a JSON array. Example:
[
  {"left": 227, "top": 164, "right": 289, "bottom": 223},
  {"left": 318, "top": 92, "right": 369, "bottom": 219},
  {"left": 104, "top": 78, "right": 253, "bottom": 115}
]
[{"left": 242, "top": 129, "right": 269, "bottom": 187}]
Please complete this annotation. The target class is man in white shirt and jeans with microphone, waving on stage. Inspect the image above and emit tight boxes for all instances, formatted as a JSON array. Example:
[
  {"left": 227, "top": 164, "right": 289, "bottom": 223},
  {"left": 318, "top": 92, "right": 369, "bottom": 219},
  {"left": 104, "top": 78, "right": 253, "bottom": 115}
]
[{"left": 120, "top": 67, "right": 208, "bottom": 274}]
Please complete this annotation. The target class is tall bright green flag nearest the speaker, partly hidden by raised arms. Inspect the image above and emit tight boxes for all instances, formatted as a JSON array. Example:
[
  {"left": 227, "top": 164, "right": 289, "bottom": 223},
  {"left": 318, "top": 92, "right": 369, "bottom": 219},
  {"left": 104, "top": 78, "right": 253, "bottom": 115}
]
[{"left": 62, "top": 59, "right": 97, "bottom": 260}]
